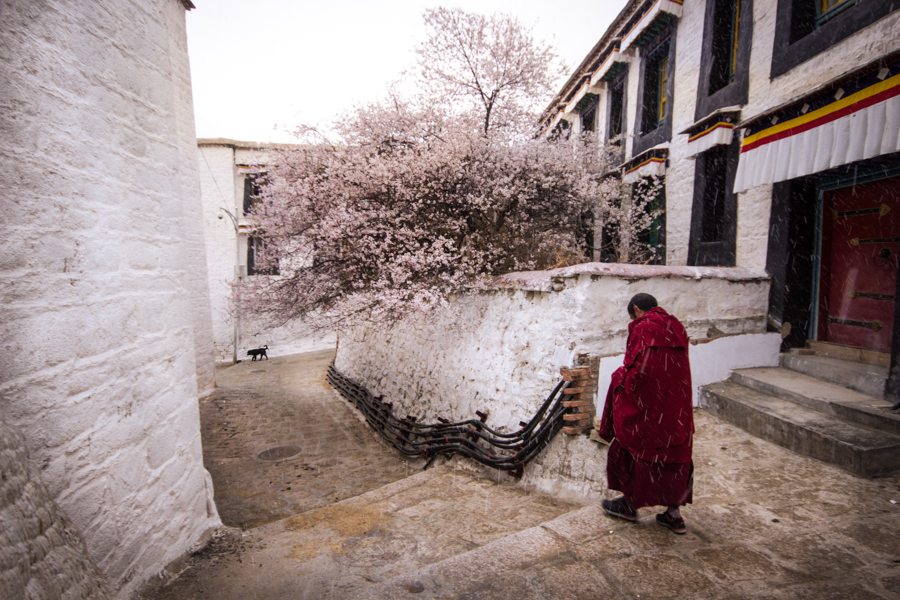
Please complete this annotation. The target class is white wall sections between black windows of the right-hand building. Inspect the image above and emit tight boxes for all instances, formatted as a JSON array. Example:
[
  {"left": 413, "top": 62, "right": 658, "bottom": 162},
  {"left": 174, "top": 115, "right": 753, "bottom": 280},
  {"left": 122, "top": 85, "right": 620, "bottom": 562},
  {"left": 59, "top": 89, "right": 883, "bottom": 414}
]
[{"left": 566, "top": 0, "right": 900, "bottom": 270}]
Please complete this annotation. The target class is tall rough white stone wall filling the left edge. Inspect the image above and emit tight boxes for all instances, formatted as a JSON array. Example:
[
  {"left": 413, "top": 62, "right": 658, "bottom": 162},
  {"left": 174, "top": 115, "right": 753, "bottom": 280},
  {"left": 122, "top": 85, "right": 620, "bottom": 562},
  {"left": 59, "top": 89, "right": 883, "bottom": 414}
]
[{"left": 0, "top": 0, "right": 219, "bottom": 598}]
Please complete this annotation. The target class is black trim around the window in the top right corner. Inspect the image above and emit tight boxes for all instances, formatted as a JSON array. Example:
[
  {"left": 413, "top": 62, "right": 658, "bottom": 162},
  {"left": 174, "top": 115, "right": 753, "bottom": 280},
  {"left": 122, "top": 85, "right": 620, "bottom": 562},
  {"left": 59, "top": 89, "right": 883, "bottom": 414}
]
[{"left": 769, "top": 0, "right": 900, "bottom": 79}]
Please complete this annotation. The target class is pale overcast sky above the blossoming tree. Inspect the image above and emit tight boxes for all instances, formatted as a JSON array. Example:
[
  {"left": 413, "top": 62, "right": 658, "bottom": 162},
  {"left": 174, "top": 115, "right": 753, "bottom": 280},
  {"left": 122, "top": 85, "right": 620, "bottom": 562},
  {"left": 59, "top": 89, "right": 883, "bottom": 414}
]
[{"left": 187, "top": 0, "right": 625, "bottom": 142}]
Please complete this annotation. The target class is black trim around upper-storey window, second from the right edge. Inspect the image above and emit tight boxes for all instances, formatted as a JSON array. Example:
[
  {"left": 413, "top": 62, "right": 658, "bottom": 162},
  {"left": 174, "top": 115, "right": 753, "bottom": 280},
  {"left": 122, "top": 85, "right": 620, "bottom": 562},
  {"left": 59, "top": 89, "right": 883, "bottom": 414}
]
[{"left": 694, "top": 0, "right": 753, "bottom": 121}]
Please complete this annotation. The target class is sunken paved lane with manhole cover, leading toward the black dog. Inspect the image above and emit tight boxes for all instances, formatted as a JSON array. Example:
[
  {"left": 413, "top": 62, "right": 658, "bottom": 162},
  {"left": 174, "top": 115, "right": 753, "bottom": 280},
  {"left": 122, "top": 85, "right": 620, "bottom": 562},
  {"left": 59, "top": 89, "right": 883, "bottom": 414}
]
[{"left": 200, "top": 350, "right": 422, "bottom": 529}]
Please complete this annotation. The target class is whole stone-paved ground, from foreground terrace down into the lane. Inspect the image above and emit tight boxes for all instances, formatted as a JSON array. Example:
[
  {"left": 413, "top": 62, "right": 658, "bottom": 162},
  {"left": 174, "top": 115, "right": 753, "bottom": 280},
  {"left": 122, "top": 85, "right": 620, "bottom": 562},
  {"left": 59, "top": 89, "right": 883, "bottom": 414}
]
[{"left": 143, "top": 355, "right": 900, "bottom": 600}]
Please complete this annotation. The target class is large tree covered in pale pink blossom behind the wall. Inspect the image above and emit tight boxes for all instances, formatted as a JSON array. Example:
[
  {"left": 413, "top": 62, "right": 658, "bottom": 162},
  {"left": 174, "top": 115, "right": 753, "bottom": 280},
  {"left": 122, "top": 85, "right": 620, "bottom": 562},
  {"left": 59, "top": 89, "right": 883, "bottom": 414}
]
[{"left": 240, "top": 9, "right": 660, "bottom": 329}]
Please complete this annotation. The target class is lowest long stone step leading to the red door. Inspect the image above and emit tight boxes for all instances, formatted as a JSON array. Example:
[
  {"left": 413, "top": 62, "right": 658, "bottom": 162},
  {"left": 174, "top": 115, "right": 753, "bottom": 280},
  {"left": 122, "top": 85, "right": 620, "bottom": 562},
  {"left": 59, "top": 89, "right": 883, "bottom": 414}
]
[{"left": 700, "top": 380, "right": 900, "bottom": 477}]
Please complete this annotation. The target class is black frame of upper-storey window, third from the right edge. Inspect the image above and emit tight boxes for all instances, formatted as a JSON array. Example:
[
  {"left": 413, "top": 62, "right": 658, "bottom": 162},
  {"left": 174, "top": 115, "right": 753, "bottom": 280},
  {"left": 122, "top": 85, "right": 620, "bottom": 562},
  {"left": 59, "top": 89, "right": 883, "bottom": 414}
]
[{"left": 631, "top": 31, "right": 678, "bottom": 156}]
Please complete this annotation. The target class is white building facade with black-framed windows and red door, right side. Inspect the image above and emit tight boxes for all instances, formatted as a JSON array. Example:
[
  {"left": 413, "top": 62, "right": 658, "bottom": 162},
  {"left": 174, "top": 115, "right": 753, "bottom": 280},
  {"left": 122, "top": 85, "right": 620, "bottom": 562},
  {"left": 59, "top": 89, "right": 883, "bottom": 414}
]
[{"left": 543, "top": 0, "right": 900, "bottom": 390}]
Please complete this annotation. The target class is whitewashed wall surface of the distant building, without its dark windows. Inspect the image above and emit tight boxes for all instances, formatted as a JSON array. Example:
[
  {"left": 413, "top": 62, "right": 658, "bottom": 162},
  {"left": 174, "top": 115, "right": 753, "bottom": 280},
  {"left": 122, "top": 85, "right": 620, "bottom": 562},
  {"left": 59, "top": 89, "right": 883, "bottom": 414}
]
[{"left": 196, "top": 140, "right": 336, "bottom": 362}]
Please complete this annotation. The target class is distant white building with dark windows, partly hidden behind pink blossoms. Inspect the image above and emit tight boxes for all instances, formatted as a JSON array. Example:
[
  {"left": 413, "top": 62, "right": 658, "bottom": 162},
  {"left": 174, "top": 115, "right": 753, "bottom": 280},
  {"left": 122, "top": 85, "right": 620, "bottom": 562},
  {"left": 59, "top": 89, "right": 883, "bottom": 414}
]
[{"left": 197, "top": 138, "right": 335, "bottom": 362}]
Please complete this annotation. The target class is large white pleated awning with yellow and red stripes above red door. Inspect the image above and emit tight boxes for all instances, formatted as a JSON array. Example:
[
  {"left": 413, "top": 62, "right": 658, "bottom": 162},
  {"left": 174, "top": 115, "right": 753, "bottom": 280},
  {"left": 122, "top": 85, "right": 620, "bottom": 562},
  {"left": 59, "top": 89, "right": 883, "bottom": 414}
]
[{"left": 734, "top": 61, "right": 900, "bottom": 193}]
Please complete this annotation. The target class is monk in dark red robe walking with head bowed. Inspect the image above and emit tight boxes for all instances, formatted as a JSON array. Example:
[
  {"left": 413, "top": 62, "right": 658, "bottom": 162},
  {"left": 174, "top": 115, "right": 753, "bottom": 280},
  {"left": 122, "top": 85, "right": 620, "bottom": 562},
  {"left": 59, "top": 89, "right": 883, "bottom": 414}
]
[{"left": 599, "top": 294, "right": 694, "bottom": 534}]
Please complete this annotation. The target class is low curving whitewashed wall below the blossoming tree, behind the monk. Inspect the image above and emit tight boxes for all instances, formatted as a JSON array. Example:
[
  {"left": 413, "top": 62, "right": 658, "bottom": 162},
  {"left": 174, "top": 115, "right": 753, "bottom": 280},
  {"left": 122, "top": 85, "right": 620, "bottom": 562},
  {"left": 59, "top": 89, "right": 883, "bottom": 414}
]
[{"left": 335, "top": 263, "right": 781, "bottom": 493}]
